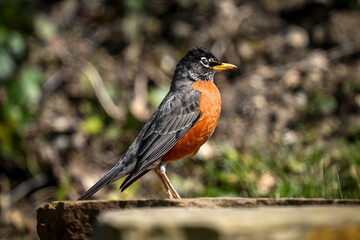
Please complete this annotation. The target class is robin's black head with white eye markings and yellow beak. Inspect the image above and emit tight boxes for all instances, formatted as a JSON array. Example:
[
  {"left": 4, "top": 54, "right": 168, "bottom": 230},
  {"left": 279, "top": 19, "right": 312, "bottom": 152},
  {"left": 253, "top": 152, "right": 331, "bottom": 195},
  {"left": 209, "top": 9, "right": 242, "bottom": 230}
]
[{"left": 171, "top": 47, "right": 236, "bottom": 87}]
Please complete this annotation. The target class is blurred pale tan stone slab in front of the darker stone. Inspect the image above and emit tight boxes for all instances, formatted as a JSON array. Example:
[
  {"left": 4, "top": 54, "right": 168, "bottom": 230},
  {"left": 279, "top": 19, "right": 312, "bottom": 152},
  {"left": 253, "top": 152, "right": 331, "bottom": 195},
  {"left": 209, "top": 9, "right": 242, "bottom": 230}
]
[{"left": 94, "top": 206, "right": 360, "bottom": 240}]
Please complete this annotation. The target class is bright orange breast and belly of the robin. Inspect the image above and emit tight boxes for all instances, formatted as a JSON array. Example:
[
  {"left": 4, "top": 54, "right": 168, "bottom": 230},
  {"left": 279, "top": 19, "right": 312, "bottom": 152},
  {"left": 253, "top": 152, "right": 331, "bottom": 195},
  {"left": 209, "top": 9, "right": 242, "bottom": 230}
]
[{"left": 162, "top": 81, "right": 221, "bottom": 162}]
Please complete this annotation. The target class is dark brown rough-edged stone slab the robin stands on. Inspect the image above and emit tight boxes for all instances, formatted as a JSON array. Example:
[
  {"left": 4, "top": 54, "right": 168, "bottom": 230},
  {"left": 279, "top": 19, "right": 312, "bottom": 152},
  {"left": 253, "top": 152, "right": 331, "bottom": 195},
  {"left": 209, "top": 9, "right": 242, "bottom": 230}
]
[{"left": 37, "top": 198, "right": 360, "bottom": 239}]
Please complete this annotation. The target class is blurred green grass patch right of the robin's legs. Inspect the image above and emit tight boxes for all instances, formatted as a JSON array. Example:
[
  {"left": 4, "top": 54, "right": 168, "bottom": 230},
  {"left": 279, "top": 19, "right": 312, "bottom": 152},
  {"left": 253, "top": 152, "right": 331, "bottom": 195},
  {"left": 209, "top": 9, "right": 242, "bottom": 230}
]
[{"left": 195, "top": 141, "right": 360, "bottom": 199}]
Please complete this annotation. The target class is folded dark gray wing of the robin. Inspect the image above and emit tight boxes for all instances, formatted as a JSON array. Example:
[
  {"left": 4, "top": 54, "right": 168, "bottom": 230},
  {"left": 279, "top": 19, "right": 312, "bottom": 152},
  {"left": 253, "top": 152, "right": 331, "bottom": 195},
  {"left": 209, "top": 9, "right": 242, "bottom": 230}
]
[{"left": 120, "top": 87, "right": 200, "bottom": 191}]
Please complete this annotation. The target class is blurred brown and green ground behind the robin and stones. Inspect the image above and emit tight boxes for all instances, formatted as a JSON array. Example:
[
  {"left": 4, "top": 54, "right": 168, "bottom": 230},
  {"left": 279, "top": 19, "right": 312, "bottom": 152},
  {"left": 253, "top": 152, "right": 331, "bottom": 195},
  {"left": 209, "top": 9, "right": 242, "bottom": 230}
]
[{"left": 0, "top": 0, "right": 360, "bottom": 239}]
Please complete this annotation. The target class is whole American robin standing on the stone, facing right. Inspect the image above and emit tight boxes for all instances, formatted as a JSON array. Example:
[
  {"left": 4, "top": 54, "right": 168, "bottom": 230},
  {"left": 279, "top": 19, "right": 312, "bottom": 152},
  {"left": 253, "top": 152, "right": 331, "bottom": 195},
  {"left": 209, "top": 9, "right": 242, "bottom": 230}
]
[{"left": 78, "top": 47, "right": 236, "bottom": 200}]
